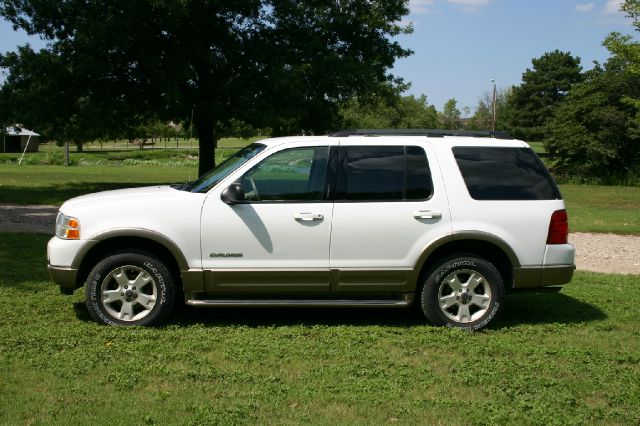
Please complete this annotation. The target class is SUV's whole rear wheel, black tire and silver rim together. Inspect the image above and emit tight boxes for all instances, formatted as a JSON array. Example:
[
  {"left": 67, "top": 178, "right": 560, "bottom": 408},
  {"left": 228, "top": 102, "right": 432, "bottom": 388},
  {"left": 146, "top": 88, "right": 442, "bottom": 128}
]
[{"left": 420, "top": 254, "right": 504, "bottom": 330}]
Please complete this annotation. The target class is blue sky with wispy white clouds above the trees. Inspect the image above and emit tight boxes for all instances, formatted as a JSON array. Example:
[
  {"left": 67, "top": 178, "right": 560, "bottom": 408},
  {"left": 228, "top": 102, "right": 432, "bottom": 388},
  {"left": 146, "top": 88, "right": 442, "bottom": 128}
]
[{"left": 0, "top": 0, "right": 638, "bottom": 114}]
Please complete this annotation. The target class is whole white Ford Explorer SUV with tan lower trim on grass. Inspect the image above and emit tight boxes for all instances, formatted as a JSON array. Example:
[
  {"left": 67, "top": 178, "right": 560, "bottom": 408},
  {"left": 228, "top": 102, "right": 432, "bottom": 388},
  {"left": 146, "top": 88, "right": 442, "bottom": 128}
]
[{"left": 47, "top": 130, "right": 575, "bottom": 329}]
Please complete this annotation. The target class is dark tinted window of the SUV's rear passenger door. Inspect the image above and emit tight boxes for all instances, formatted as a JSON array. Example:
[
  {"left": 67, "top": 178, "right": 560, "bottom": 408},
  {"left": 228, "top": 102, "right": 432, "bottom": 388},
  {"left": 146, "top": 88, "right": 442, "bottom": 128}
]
[{"left": 336, "top": 146, "right": 433, "bottom": 201}]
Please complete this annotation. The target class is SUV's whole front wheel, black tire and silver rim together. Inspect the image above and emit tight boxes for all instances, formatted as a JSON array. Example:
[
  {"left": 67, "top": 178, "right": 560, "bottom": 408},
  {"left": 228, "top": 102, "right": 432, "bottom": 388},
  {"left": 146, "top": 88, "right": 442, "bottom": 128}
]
[{"left": 85, "top": 251, "right": 175, "bottom": 326}]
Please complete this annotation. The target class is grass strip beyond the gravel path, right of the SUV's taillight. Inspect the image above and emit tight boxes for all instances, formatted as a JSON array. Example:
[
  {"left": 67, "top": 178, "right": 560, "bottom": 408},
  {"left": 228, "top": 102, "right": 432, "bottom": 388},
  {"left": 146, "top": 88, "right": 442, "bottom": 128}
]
[{"left": 560, "top": 184, "right": 640, "bottom": 235}]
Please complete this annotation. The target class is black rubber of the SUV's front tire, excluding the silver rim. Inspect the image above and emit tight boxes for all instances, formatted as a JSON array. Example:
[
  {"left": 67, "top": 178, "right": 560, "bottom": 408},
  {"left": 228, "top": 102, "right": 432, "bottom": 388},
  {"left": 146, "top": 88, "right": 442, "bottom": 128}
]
[{"left": 85, "top": 252, "right": 175, "bottom": 326}]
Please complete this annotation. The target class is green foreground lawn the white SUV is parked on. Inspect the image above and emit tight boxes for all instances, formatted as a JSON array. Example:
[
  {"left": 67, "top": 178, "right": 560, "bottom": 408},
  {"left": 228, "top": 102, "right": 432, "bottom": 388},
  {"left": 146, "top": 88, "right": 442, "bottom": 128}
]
[{"left": 0, "top": 234, "right": 640, "bottom": 425}]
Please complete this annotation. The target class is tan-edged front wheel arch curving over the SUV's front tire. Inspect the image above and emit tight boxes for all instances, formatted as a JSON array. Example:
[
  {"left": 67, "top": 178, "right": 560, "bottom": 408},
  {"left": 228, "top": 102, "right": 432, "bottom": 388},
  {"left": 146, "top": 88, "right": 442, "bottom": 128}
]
[{"left": 72, "top": 229, "right": 188, "bottom": 287}]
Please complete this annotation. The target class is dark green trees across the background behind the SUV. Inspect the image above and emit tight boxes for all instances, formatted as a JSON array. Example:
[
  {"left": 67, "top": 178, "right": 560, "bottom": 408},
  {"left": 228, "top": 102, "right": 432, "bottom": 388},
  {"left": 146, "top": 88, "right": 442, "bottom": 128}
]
[{"left": 0, "top": 0, "right": 640, "bottom": 183}]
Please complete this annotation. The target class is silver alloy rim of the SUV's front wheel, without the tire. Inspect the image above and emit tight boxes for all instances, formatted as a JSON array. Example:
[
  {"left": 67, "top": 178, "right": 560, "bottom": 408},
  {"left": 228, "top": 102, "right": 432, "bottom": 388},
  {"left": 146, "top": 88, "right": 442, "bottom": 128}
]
[{"left": 100, "top": 265, "right": 158, "bottom": 322}]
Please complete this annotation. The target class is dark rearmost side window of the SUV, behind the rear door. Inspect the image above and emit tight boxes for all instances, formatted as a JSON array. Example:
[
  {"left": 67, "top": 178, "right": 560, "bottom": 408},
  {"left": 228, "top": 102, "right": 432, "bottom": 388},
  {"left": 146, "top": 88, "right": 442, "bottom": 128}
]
[{"left": 453, "top": 147, "right": 562, "bottom": 200}]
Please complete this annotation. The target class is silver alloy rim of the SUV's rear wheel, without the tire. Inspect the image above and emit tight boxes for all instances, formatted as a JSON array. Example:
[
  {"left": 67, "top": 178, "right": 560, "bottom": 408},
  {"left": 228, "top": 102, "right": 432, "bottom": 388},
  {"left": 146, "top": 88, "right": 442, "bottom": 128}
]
[{"left": 438, "top": 269, "right": 491, "bottom": 324}]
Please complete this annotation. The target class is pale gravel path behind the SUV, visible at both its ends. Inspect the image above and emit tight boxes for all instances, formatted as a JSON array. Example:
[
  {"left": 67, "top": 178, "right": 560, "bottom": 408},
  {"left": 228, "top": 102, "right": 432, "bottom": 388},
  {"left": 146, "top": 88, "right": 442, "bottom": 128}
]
[{"left": 0, "top": 204, "right": 640, "bottom": 275}]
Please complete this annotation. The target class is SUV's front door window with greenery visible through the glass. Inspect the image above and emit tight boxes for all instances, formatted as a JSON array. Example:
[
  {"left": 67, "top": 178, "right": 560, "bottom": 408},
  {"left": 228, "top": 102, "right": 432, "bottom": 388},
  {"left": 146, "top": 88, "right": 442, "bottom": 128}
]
[{"left": 242, "top": 146, "right": 329, "bottom": 201}]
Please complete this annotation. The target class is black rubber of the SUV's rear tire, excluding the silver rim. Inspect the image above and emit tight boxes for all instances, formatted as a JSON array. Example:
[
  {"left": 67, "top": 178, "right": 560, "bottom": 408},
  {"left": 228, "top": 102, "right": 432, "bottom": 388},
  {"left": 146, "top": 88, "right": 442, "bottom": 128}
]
[{"left": 420, "top": 256, "right": 504, "bottom": 331}]
